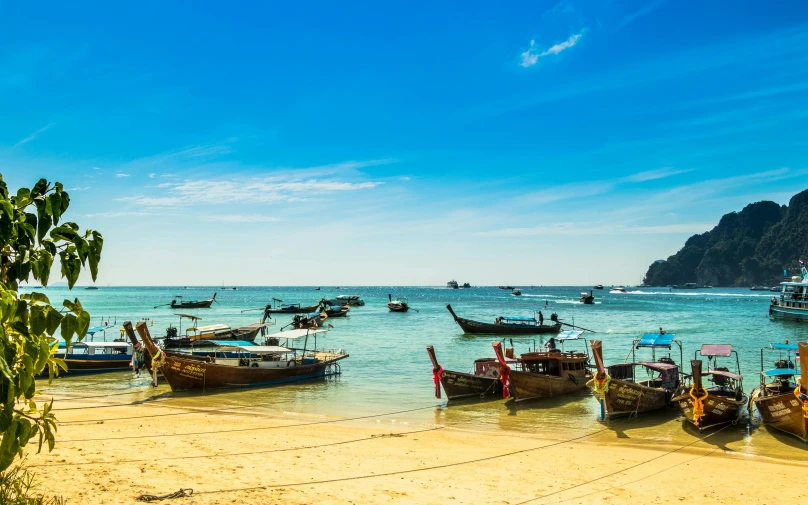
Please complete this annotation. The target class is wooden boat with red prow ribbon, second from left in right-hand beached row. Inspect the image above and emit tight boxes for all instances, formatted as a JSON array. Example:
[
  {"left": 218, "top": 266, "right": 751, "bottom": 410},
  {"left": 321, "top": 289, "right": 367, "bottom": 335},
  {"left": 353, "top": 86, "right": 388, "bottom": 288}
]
[{"left": 492, "top": 331, "right": 592, "bottom": 402}]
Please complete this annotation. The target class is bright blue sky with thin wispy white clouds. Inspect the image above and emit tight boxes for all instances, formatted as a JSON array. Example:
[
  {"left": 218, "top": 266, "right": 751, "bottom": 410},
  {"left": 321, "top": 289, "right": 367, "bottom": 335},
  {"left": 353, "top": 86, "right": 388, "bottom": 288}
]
[{"left": 0, "top": 0, "right": 808, "bottom": 286}]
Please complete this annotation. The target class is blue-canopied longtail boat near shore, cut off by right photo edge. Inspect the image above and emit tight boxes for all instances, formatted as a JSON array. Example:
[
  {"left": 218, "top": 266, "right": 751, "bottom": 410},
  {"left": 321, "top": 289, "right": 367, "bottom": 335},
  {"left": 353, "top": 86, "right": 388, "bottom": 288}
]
[{"left": 749, "top": 342, "right": 808, "bottom": 442}]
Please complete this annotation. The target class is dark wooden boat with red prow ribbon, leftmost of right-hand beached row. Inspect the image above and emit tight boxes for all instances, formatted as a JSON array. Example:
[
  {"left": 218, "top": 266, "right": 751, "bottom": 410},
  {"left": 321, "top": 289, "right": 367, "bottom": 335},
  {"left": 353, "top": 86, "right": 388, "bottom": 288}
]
[{"left": 426, "top": 345, "right": 502, "bottom": 400}]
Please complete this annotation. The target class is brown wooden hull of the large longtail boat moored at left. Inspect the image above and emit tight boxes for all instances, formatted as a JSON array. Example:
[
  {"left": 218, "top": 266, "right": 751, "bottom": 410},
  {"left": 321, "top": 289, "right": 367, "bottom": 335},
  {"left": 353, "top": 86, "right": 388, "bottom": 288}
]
[{"left": 161, "top": 355, "right": 347, "bottom": 391}]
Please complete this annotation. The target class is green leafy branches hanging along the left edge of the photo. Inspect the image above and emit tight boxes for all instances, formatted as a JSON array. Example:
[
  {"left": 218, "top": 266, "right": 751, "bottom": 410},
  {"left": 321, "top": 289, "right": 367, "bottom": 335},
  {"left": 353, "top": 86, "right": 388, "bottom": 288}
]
[{"left": 0, "top": 175, "right": 104, "bottom": 472}]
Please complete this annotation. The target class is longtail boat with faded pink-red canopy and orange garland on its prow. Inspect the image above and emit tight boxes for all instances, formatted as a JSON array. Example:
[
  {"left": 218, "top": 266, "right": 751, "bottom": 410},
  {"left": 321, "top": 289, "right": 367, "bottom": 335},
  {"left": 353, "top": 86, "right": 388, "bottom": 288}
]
[{"left": 672, "top": 344, "right": 749, "bottom": 430}]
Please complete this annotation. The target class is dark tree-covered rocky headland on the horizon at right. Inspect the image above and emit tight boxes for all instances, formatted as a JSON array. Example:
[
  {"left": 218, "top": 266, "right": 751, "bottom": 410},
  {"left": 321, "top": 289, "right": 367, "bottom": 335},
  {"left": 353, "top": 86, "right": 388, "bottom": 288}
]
[{"left": 643, "top": 190, "right": 808, "bottom": 287}]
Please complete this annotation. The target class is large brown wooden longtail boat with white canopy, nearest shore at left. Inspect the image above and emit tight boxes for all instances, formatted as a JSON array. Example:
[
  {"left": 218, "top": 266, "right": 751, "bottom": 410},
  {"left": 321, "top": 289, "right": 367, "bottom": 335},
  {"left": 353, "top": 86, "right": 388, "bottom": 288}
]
[{"left": 131, "top": 321, "right": 348, "bottom": 391}]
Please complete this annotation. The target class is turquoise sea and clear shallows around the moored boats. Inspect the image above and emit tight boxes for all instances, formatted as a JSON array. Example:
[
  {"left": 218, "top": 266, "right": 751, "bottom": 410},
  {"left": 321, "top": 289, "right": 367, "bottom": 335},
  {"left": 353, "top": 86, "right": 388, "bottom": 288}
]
[{"left": 34, "top": 286, "right": 808, "bottom": 461}]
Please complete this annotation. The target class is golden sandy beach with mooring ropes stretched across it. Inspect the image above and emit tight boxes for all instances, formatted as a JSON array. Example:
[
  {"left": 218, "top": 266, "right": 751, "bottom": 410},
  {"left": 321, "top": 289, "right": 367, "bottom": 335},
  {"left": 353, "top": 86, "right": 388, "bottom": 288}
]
[{"left": 28, "top": 396, "right": 808, "bottom": 505}]
